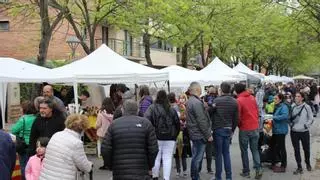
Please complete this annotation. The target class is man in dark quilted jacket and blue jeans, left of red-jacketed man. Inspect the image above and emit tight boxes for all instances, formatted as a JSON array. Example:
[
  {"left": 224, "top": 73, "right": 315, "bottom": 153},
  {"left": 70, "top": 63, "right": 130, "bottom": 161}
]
[{"left": 209, "top": 83, "right": 239, "bottom": 180}]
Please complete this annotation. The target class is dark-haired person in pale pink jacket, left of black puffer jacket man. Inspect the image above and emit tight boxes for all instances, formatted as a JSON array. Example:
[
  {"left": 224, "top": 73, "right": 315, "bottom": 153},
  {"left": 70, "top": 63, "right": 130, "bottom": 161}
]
[{"left": 96, "top": 97, "right": 115, "bottom": 170}]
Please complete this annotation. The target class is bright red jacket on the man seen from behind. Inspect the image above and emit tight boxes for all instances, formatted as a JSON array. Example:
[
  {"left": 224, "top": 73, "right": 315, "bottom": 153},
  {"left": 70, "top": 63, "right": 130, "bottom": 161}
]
[{"left": 237, "top": 91, "right": 259, "bottom": 131}]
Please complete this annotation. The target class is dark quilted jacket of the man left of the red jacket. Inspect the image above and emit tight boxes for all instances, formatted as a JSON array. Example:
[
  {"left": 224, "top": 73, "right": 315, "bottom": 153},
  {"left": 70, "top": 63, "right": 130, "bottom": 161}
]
[{"left": 209, "top": 95, "right": 239, "bottom": 132}]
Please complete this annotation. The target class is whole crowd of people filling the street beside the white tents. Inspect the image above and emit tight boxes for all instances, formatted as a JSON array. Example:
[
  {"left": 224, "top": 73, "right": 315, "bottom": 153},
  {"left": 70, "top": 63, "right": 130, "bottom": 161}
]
[{"left": 0, "top": 82, "right": 320, "bottom": 180}]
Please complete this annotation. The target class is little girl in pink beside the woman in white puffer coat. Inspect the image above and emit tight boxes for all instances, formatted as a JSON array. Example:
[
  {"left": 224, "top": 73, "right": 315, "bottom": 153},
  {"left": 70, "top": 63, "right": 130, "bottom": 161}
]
[{"left": 25, "top": 137, "right": 49, "bottom": 180}]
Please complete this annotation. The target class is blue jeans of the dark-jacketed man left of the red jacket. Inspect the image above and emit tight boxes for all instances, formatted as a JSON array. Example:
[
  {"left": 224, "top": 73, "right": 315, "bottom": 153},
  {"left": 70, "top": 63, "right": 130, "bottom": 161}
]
[{"left": 214, "top": 128, "right": 232, "bottom": 180}]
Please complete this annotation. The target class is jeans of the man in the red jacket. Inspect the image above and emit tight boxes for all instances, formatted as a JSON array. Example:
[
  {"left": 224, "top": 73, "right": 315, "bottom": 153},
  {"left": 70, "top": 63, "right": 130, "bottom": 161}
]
[{"left": 239, "top": 129, "right": 261, "bottom": 173}]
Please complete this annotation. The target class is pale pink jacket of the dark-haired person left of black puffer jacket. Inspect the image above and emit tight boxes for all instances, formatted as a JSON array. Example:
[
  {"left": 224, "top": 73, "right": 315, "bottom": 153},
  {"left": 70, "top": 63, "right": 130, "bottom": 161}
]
[{"left": 96, "top": 111, "right": 113, "bottom": 137}]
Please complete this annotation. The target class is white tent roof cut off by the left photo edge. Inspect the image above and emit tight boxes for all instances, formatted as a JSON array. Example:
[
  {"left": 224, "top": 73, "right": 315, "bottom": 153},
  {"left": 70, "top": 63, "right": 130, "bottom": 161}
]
[{"left": 0, "top": 58, "right": 66, "bottom": 83}]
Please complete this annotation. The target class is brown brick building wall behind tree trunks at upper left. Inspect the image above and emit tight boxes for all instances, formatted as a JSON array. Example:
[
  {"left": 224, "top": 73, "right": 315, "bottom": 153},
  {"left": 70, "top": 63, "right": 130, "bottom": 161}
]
[{"left": 0, "top": 10, "right": 89, "bottom": 60}]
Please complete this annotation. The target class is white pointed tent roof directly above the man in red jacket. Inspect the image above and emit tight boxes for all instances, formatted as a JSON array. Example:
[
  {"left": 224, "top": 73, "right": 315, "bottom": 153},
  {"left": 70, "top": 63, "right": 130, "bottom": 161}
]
[{"left": 200, "top": 57, "right": 246, "bottom": 81}]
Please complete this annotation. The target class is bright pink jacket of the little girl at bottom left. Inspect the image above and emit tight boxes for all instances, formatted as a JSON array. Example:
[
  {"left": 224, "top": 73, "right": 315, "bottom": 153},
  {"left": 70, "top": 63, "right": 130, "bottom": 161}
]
[{"left": 25, "top": 155, "right": 43, "bottom": 180}]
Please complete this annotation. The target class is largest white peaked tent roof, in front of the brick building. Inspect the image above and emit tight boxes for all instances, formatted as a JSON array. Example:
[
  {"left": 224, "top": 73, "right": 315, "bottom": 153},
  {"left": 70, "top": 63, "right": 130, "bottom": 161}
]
[{"left": 53, "top": 44, "right": 169, "bottom": 83}]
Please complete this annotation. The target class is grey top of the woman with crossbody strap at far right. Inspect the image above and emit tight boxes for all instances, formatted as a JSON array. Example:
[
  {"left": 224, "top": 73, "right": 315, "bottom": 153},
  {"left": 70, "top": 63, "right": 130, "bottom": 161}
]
[{"left": 291, "top": 103, "right": 313, "bottom": 132}]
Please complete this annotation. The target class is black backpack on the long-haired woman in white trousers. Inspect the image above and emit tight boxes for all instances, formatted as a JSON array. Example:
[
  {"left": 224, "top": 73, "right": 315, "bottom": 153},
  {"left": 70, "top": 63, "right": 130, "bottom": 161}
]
[{"left": 152, "top": 105, "right": 178, "bottom": 140}]
